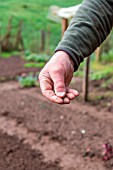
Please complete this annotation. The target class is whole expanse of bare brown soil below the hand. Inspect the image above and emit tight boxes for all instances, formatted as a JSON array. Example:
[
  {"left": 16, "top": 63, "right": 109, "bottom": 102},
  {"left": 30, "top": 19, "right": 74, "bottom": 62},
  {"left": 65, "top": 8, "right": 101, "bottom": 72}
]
[{"left": 0, "top": 55, "right": 113, "bottom": 170}]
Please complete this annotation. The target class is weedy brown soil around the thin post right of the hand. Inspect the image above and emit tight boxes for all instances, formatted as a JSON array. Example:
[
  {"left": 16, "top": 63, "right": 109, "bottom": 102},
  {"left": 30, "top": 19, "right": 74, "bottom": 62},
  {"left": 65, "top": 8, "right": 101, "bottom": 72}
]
[{"left": 71, "top": 77, "right": 113, "bottom": 112}]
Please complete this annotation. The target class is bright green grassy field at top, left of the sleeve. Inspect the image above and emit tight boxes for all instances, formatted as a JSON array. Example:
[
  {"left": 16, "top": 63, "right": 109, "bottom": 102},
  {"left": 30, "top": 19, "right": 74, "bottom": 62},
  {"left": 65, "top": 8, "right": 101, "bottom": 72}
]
[{"left": 0, "top": 0, "right": 82, "bottom": 52}]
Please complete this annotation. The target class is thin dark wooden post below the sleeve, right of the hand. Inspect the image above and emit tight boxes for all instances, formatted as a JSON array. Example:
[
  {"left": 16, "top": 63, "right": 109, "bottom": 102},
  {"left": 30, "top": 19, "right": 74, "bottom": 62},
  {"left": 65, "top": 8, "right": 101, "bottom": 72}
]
[{"left": 83, "top": 56, "right": 90, "bottom": 102}]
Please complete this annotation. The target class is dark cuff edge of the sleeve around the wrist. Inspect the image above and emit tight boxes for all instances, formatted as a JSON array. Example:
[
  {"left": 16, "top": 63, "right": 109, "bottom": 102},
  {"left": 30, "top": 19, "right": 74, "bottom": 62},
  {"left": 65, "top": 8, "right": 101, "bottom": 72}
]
[{"left": 55, "top": 47, "right": 79, "bottom": 72}]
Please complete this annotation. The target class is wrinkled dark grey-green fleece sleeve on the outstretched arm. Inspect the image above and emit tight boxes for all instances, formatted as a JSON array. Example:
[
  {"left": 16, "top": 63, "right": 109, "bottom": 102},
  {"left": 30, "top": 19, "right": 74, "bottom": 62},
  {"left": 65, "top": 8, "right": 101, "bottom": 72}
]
[{"left": 55, "top": 0, "right": 113, "bottom": 71}]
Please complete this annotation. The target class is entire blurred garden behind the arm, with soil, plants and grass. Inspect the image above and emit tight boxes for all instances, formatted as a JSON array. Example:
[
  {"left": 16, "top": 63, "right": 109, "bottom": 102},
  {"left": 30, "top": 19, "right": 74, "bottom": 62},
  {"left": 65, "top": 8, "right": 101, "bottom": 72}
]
[{"left": 0, "top": 0, "right": 113, "bottom": 170}]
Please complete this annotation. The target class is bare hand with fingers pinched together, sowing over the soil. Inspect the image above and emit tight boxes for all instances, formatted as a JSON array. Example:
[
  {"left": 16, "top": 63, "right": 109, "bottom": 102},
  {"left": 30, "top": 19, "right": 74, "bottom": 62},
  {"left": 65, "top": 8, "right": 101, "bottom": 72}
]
[{"left": 39, "top": 51, "right": 79, "bottom": 104}]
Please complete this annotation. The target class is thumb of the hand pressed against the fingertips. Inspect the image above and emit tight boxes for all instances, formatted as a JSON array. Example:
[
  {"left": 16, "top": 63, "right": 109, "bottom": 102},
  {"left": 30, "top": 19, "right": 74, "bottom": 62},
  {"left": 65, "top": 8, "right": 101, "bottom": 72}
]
[{"left": 51, "top": 71, "right": 66, "bottom": 98}]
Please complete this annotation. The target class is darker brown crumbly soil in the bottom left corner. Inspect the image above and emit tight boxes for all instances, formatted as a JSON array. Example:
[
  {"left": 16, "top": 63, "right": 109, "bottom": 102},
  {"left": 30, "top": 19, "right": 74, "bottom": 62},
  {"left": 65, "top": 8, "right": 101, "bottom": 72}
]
[{"left": 0, "top": 133, "right": 61, "bottom": 170}]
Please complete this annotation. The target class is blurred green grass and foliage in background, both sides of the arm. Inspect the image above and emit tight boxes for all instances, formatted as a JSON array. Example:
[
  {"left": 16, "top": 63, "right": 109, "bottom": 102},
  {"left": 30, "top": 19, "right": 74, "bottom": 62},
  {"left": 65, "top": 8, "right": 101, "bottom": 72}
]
[{"left": 0, "top": 0, "right": 113, "bottom": 85}]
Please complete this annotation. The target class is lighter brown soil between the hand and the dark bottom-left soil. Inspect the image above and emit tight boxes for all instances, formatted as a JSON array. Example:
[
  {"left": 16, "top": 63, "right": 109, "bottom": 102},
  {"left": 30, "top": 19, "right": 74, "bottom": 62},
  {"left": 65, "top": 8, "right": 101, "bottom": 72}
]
[{"left": 0, "top": 82, "right": 113, "bottom": 170}]
